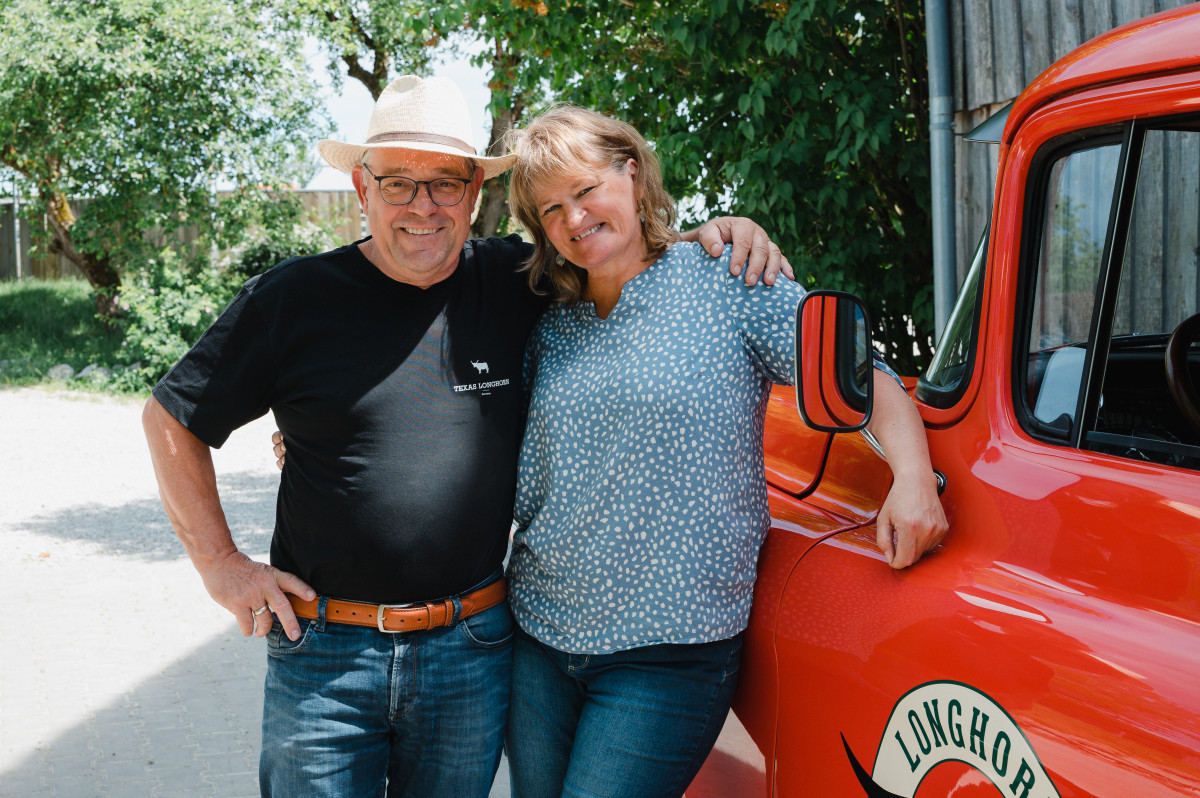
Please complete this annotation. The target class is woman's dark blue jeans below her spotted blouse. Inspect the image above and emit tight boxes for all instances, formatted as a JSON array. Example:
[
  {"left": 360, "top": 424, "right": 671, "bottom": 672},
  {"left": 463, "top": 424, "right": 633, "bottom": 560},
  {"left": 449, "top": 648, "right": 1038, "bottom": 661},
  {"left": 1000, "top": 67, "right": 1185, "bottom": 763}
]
[{"left": 505, "top": 629, "right": 742, "bottom": 798}]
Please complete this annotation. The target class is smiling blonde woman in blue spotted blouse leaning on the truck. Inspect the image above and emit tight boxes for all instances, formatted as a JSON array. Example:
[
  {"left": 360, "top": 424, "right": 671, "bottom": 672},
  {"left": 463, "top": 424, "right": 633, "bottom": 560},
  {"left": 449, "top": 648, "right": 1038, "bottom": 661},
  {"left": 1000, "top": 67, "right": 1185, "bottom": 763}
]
[{"left": 506, "top": 107, "right": 946, "bottom": 798}]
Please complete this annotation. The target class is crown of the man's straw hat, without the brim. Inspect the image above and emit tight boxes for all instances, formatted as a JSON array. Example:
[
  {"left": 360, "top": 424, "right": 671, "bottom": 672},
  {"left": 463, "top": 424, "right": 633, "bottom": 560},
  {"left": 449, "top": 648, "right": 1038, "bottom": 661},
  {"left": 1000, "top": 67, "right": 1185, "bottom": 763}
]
[{"left": 367, "top": 74, "right": 475, "bottom": 157}]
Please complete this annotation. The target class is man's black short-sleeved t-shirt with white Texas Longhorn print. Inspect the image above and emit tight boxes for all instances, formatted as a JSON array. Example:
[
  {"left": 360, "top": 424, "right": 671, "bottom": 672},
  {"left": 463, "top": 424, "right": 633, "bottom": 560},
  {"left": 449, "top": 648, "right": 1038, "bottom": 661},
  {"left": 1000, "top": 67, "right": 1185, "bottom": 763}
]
[{"left": 154, "top": 236, "right": 546, "bottom": 604}]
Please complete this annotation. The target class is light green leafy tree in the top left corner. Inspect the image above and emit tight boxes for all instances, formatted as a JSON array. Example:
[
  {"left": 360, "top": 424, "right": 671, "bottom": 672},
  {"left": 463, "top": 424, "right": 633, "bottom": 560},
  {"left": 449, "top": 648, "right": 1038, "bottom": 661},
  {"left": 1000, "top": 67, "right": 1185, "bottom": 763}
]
[{"left": 0, "top": 0, "right": 319, "bottom": 314}]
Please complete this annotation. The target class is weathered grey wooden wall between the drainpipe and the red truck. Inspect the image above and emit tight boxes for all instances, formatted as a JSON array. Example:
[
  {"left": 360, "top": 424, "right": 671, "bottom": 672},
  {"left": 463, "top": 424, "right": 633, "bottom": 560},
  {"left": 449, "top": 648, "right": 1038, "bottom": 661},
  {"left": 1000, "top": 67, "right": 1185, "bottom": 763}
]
[{"left": 950, "top": 0, "right": 1188, "bottom": 284}]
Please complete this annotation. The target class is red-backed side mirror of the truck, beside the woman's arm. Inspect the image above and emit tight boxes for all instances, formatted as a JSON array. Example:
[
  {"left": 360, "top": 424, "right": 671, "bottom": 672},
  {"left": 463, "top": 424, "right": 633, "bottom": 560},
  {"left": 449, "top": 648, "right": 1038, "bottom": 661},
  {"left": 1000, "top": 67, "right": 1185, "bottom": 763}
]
[{"left": 796, "top": 290, "right": 875, "bottom": 432}]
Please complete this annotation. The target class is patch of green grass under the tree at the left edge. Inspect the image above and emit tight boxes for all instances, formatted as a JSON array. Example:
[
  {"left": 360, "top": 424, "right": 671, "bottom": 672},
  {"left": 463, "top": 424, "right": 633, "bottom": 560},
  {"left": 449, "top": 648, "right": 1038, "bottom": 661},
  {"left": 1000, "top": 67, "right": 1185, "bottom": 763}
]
[{"left": 0, "top": 278, "right": 140, "bottom": 392}]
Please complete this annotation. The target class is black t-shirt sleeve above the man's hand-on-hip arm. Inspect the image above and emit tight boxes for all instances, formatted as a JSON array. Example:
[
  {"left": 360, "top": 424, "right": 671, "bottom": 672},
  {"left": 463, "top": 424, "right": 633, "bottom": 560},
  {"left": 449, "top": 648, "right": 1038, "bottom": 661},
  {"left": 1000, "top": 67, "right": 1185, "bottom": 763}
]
[{"left": 154, "top": 281, "right": 275, "bottom": 449}]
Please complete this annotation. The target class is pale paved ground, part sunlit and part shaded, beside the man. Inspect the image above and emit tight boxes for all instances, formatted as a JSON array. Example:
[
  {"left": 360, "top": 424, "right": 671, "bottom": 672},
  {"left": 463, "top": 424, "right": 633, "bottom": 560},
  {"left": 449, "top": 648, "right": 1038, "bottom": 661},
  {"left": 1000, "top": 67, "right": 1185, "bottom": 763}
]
[{"left": 0, "top": 389, "right": 508, "bottom": 798}]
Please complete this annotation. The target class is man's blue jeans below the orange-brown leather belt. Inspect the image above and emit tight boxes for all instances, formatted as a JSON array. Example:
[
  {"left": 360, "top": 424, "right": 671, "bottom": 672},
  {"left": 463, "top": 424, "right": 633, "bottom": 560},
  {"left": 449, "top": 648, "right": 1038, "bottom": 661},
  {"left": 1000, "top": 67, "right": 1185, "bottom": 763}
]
[{"left": 259, "top": 585, "right": 512, "bottom": 798}]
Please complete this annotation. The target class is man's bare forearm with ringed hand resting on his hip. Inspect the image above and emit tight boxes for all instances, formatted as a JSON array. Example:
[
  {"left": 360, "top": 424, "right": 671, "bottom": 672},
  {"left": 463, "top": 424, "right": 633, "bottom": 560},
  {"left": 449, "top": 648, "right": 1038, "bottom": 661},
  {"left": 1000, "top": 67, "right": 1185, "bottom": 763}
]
[{"left": 142, "top": 397, "right": 316, "bottom": 640}]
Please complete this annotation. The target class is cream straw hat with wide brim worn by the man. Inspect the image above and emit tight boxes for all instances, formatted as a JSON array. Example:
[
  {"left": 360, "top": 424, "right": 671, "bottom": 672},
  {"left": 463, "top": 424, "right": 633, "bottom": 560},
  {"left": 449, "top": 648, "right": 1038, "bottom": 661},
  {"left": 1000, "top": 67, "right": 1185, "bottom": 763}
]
[{"left": 317, "top": 74, "right": 516, "bottom": 180}]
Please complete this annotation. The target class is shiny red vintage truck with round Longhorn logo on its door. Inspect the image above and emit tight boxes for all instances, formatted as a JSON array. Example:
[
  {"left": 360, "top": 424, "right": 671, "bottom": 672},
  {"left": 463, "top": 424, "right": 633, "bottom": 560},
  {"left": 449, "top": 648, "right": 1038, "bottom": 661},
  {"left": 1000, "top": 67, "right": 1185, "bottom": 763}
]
[{"left": 688, "top": 4, "right": 1200, "bottom": 798}]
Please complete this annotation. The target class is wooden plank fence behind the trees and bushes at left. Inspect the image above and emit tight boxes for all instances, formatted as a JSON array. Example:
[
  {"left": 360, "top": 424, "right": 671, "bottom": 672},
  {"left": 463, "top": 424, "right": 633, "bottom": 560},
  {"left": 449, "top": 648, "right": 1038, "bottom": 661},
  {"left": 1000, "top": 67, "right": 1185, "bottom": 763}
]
[{"left": 0, "top": 191, "right": 366, "bottom": 280}]
